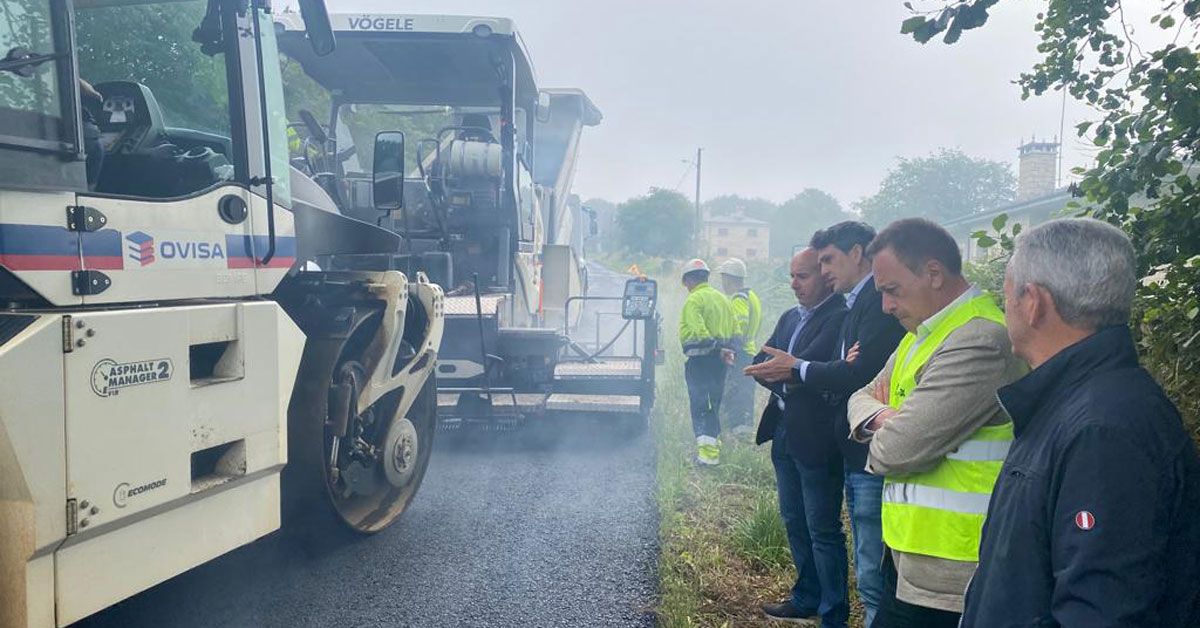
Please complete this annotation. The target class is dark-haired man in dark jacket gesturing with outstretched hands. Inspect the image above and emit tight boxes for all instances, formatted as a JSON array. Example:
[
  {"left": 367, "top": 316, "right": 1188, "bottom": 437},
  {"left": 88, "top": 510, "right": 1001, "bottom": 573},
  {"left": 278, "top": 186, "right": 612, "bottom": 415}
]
[{"left": 744, "top": 221, "right": 905, "bottom": 626}]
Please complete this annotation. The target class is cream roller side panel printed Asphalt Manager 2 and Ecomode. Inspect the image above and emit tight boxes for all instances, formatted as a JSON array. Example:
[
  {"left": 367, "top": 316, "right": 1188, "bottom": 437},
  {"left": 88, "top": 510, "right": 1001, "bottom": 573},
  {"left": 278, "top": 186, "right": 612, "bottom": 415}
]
[{"left": 66, "top": 301, "right": 292, "bottom": 528}]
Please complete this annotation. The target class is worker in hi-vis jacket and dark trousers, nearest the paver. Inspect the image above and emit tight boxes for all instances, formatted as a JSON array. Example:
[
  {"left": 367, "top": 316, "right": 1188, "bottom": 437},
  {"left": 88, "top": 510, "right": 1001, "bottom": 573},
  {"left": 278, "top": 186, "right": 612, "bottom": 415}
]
[{"left": 679, "top": 259, "right": 733, "bottom": 465}]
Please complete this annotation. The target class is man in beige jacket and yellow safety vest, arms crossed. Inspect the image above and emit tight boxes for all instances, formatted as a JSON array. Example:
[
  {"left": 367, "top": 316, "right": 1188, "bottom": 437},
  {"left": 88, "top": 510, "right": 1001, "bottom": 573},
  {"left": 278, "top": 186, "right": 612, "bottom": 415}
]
[{"left": 847, "top": 219, "right": 1026, "bottom": 628}]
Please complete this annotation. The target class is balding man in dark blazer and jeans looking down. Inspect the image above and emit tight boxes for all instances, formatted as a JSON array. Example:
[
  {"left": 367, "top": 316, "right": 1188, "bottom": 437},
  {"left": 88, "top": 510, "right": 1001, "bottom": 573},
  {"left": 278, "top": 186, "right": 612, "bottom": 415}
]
[{"left": 746, "top": 249, "right": 850, "bottom": 627}]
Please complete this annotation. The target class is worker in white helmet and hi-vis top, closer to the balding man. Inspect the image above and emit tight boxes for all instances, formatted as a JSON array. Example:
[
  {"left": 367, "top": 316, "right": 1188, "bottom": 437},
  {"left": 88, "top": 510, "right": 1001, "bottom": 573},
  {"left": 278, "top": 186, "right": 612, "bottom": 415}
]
[{"left": 716, "top": 257, "right": 762, "bottom": 436}]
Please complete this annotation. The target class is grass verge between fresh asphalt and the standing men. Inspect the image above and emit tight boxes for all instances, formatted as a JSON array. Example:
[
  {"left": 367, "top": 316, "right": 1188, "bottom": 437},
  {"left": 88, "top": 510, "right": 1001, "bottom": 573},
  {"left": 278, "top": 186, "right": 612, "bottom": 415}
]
[{"left": 652, "top": 279, "right": 862, "bottom": 628}]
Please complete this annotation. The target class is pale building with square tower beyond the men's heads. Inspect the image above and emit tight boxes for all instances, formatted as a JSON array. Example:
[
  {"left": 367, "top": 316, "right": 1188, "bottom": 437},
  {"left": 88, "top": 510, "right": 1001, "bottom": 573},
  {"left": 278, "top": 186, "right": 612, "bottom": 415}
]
[{"left": 943, "top": 140, "right": 1072, "bottom": 261}]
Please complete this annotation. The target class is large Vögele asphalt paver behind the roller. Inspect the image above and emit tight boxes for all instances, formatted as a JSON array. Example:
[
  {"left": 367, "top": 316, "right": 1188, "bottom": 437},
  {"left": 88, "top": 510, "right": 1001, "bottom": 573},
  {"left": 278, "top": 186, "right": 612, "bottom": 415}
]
[{"left": 277, "top": 14, "right": 659, "bottom": 426}]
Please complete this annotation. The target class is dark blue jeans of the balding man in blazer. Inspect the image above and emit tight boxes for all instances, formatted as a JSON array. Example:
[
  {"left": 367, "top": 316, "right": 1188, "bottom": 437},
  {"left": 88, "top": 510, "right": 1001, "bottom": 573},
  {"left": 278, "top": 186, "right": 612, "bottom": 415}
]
[{"left": 770, "top": 424, "right": 850, "bottom": 628}]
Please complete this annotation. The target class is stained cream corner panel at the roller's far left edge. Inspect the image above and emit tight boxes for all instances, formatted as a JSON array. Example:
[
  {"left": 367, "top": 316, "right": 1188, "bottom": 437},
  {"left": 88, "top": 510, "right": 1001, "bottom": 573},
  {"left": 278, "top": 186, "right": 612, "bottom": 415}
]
[{"left": 0, "top": 315, "right": 66, "bottom": 626}]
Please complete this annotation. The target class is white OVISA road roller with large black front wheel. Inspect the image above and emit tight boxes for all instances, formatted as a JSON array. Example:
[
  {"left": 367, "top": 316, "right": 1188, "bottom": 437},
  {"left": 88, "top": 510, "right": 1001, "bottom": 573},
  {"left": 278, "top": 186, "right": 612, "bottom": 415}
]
[{"left": 0, "top": 0, "right": 444, "bottom": 627}]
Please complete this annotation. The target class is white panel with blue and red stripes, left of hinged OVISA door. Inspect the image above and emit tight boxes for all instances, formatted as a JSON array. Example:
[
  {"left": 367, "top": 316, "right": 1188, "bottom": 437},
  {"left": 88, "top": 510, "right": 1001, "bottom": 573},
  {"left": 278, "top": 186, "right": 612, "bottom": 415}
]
[{"left": 0, "top": 190, "right": 83, "bottom": 305}]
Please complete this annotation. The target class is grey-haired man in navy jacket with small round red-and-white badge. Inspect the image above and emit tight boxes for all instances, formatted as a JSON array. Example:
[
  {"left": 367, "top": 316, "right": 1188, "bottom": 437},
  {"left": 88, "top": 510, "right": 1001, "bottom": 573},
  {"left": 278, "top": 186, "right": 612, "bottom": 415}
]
[{"left": 961, "top": 219, "right": 1200, "bottom": 628}]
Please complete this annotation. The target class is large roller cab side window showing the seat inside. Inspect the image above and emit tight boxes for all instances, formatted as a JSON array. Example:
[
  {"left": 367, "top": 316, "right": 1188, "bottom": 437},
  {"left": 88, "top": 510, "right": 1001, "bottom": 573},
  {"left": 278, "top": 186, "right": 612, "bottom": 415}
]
[{"left": 76, "top": 0, "right": 245, "bottom": 198}]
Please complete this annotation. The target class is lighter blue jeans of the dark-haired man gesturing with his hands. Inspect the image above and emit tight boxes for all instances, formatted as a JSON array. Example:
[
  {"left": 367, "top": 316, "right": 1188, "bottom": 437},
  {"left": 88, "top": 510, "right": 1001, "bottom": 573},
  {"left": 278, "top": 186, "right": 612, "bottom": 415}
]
[{"left": 846, "top": 468, "right": 883, "bottom": 626}]
